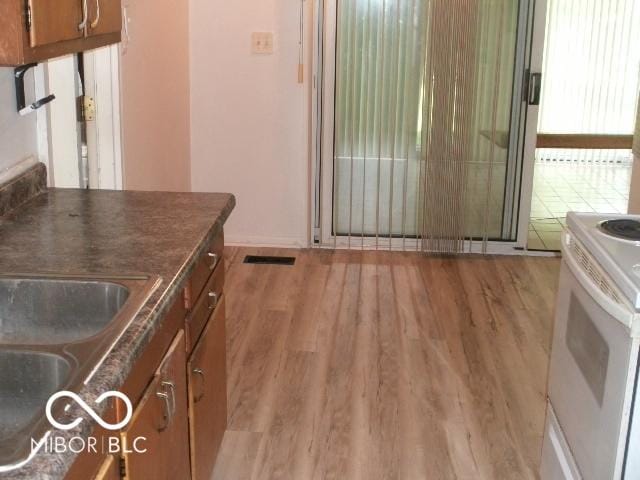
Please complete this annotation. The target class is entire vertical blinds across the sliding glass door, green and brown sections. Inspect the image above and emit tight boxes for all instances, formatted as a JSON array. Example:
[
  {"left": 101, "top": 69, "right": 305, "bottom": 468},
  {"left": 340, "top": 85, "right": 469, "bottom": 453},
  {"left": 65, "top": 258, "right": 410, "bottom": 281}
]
[{"left": 333, "top": 0, "right": 519, "bottom": 252}]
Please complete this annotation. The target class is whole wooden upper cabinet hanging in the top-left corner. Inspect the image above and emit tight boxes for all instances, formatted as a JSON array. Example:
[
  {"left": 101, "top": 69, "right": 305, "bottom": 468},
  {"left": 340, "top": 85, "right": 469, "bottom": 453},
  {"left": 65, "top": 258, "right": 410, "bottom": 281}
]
[{"left": 0, "top": 0, "right": 122, "bottom": 66}]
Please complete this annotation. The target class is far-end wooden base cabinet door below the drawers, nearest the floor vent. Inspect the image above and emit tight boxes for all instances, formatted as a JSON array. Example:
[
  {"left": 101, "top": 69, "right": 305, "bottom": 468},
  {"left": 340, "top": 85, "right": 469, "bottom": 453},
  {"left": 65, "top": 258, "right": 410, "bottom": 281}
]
[{"left": 188, "top": 296, "right": 227, "bottom": 480}]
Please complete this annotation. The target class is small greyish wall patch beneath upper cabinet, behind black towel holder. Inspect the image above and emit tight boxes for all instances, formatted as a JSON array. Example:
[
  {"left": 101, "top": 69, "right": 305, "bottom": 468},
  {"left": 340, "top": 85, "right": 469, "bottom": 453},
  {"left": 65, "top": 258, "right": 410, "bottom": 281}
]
[{"left": 0, "top": 67, "right": 38, "bottom": 172}]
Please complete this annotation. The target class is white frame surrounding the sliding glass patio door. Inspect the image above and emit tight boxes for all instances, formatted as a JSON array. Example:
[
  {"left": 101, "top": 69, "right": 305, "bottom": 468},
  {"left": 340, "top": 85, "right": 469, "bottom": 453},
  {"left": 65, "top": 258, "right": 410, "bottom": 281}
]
[{"left": 309, "top": 0, "right": 547, "bottom": 253}]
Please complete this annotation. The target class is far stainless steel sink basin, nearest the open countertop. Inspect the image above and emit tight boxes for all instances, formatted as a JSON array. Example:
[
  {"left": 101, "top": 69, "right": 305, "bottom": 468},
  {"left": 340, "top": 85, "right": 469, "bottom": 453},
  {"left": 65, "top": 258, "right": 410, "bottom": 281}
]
[{"left": 0, "top": 278, "right": 129, "bottom": 345}]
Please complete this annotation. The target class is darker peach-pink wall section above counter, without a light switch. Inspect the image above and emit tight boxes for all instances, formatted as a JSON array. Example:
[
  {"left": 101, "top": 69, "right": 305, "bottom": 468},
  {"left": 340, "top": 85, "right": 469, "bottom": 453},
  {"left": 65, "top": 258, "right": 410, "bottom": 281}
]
[{"left": 120, "top": 0, "right": 191, "bottom": 191}]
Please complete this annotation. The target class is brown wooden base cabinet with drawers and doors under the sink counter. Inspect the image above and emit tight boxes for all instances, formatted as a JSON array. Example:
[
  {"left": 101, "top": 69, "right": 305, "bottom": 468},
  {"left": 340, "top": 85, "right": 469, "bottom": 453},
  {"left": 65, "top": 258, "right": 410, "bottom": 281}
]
[{"left": 65, "top": 232, "right": 227, "bottom": 480}]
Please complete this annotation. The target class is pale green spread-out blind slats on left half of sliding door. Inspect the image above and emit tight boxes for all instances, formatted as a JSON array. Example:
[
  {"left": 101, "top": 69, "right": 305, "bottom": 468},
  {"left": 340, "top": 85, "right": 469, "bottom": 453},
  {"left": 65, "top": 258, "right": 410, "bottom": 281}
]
[{"left": 334, "top": 0, "right": 428, "bottom": 242}]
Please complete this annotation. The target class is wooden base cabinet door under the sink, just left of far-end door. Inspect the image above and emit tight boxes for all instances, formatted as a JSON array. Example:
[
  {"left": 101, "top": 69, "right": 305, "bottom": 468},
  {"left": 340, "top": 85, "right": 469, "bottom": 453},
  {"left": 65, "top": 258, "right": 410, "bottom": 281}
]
[{"left": 122, "top": 330, "right": 191, "bottom": 480}]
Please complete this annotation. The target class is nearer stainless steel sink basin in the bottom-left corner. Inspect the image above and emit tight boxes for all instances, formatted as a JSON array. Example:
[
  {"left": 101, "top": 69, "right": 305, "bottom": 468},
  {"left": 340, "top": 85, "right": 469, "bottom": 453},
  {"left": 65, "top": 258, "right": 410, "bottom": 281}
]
[{"left": 0, "top": 350, "right": 72, "bottom": 465}]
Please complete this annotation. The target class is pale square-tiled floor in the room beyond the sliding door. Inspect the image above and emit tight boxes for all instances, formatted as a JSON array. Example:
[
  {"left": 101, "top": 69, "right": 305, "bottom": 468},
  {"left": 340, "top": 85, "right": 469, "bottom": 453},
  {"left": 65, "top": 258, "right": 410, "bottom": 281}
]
[{"left": 528, "top": 161, "right": 631, "bottom": 250}]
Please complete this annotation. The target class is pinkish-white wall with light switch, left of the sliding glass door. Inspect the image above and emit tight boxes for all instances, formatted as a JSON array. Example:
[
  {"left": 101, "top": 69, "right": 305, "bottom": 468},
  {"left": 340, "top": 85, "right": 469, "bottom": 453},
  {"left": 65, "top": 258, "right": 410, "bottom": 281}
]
[{"left": 190, "top": 0, "right": 312, "bottom": 246}]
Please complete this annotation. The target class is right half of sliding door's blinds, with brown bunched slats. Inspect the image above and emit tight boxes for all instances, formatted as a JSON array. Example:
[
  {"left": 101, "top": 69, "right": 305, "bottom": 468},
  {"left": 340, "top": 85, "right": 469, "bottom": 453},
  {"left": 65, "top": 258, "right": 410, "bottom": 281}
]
[{"left": 419, "top": 0, "right": 518, "bottom": 252}]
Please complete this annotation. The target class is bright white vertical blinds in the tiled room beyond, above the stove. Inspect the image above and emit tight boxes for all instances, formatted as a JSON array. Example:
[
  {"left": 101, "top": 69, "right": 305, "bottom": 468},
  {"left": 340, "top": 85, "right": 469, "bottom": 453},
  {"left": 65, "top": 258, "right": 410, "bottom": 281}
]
[{"left": 537, "top": 0, "right": 640, "bottom": 161}]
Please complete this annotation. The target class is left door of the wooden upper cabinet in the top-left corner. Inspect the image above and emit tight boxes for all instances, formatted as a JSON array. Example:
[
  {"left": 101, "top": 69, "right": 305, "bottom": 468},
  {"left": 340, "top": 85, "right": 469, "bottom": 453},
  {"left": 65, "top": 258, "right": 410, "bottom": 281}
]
[{"left": 29, "top": 0, "right": 84, "bottom": 47}]
